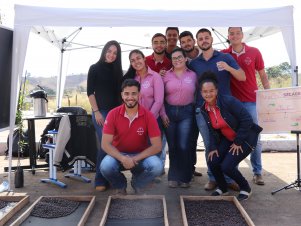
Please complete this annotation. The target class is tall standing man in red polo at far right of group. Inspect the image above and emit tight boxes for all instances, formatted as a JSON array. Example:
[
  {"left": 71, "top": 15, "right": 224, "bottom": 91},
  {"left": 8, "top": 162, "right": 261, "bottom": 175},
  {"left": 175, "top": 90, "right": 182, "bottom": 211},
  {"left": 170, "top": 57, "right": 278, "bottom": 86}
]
[{"left": 222, "top": 27, "right": 270, "bottom": 185}]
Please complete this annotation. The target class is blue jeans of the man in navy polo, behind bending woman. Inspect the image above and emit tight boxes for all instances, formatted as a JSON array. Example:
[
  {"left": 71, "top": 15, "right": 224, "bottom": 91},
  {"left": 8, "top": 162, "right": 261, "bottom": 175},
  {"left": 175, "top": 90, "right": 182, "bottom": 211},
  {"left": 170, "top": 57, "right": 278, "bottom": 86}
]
[{"left": 195, "top": 112, "right": 233, "bottom": 184}]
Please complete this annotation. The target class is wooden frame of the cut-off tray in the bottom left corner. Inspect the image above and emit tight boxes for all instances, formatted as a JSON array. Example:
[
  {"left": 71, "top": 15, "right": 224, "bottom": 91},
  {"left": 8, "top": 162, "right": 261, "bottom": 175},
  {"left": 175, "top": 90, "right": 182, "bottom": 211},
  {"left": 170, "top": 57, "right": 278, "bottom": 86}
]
[{"left": 0, "top": 195, "right": 29, "bottom": 225}]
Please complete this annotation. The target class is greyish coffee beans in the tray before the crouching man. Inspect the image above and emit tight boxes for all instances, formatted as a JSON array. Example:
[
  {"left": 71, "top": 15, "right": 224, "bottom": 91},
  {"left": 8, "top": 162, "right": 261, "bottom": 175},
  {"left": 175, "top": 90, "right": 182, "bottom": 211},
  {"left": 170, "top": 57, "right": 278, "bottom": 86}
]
[{"left": 108, "top": 198, "right": 164, "bottom": 219}]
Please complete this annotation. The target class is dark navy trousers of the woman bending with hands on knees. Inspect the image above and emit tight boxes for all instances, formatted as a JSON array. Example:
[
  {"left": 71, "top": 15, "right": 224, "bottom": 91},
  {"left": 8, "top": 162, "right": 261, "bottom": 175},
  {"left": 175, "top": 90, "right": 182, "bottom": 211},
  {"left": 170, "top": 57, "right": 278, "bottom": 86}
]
[{"left": 208, "top": 137, "right": 252, "bottom": 192}]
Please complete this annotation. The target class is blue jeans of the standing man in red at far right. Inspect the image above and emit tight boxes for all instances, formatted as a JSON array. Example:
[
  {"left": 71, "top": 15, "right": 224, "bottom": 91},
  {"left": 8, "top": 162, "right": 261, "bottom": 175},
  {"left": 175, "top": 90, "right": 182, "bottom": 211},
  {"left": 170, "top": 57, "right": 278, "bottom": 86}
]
[{"left": 242, "top": 102, "right": 262, "bottom": 175}]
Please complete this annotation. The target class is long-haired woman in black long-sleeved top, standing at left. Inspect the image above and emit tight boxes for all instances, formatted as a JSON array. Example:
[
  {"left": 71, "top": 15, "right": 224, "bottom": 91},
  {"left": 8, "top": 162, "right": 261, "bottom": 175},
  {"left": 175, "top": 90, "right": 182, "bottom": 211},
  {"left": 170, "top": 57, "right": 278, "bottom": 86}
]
[{"left": 87, "top": 40, "right": 123, "bottom": 191}]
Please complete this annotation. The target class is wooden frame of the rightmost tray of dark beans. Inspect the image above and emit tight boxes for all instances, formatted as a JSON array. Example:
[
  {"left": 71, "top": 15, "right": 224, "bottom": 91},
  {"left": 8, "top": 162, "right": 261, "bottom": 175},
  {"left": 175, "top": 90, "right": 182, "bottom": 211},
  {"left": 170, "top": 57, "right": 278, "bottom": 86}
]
[{"left": 180, "top": 196, "right": 255, "bottom": 226}]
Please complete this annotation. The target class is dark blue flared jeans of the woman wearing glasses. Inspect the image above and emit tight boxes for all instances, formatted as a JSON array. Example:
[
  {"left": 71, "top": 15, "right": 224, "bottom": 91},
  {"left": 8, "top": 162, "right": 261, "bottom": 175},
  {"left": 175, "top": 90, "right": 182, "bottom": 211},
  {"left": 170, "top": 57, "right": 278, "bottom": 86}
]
[{"left": 165, "top": 104, "right": 194, "bottom": 183}]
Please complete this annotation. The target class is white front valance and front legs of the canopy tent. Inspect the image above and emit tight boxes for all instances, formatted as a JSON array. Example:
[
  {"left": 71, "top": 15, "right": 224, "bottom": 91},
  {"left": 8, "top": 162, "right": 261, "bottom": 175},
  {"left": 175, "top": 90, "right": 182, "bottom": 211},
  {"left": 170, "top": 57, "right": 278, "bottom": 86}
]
[{"left": 9, "top": 5, "right": 297, "bottom": 189}]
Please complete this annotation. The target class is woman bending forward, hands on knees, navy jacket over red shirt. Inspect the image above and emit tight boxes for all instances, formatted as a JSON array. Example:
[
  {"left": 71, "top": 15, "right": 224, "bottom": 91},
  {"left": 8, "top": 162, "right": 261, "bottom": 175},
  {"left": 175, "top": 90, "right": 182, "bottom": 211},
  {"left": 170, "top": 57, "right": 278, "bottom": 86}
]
[{"left": 199, "top": 72, "right": 262, "bottom": 201}]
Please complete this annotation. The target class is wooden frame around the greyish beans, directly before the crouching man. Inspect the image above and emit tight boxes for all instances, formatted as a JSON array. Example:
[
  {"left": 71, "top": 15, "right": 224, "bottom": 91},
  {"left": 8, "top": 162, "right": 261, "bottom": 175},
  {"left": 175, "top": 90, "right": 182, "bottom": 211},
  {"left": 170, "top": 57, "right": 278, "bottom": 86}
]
[{"left": 99, "top": 195, "right": 169, "bottom": 226}]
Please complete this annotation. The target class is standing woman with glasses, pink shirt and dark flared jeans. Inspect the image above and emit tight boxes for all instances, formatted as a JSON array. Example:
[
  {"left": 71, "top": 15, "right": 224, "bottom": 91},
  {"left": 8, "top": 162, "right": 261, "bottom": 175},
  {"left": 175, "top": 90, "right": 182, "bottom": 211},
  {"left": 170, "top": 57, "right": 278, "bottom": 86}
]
[{"left": 161, "top": 48, "right": 197, "bottom": 188}]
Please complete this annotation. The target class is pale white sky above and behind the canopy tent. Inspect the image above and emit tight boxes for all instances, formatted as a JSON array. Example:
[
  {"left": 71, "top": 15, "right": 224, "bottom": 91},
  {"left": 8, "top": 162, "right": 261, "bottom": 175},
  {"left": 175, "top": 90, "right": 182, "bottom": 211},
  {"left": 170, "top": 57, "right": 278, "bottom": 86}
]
[{"left": 0, "top": 0, "right": 301, "bottom": 76}]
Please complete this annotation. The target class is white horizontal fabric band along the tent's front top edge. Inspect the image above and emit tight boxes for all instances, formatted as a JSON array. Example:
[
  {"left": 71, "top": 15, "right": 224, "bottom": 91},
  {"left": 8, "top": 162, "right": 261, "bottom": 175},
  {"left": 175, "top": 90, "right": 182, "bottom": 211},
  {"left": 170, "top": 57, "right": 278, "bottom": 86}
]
[{"left": 15, "top": 5, "right": 293, "bottom": 27}]
